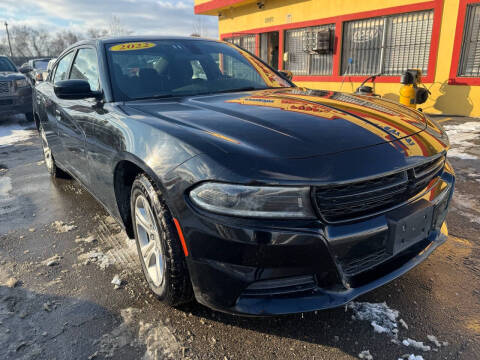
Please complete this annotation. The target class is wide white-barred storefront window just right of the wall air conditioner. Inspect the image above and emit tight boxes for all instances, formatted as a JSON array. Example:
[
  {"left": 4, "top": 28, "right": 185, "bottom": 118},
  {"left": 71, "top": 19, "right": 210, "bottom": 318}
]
[{"left": 342, "top": 10, "right": 433, "bottom": 75}]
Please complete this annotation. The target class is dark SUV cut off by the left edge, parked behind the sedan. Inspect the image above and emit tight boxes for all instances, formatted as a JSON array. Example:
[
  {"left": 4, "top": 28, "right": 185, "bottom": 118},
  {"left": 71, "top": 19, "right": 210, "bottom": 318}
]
[{"left": 0, "top": 56, "right": 33, "bottom": 121}]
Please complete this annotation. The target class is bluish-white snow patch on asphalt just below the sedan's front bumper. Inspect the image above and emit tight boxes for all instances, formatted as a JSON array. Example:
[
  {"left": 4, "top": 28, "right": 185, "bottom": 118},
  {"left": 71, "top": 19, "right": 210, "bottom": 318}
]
[{"left": 348, "top": 302, "right": 399, "bottom": 336}]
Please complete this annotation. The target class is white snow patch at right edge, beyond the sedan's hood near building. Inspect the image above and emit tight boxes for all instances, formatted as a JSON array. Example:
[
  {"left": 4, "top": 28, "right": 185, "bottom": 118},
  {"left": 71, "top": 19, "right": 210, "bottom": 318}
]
[{"left": 443, "top": 122, "right": 480, "bottom": 160}]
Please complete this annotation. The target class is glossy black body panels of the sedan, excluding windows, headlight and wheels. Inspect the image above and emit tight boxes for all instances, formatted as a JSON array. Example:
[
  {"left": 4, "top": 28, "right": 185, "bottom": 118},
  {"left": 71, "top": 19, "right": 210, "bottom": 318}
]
[{"left": 34, "top": 37, "right": 454, "bottom": 315}]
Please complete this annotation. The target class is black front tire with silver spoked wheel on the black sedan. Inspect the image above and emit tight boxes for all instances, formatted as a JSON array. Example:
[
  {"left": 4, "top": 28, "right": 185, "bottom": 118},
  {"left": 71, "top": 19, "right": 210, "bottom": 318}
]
[{"left": 130, "top": 174, "right": 193, "bottom": 306}]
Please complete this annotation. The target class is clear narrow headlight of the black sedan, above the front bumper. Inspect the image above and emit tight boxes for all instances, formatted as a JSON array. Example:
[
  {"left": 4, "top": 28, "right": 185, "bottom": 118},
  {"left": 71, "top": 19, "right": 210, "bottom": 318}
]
[{"left": 190, "top": 182, "right": 316, "bottom": 219}]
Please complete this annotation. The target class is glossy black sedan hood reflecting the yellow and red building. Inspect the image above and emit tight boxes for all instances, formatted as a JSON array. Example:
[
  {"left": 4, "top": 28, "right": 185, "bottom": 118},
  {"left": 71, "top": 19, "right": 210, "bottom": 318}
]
[{"left": 127, "top": 88, "right": 426, "bottom": 158}]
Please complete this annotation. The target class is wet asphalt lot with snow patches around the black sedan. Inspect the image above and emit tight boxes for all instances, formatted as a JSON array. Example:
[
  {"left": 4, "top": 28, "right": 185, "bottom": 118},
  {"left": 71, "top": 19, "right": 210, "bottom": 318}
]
[{"left": 0, "top": 117, "right": 480, "bottom": 360}]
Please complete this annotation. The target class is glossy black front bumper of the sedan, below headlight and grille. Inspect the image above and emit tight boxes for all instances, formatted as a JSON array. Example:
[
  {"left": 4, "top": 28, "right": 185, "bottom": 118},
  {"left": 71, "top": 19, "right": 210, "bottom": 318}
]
[{"left": 182, "top": 166, "right": 454, "bottom": 316}]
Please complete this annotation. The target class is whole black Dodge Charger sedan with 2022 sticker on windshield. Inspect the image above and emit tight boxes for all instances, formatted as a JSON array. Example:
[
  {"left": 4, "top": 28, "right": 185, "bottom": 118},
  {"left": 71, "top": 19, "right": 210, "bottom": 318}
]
[{"left": 34, "top": 37, "right": 455, "bottom": 315}]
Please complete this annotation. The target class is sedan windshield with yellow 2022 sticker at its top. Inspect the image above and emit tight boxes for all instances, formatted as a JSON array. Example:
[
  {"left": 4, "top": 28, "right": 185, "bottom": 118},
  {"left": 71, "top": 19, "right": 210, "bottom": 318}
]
[{"left": 106, "top": 40, "right": 292, "bottom": 101}]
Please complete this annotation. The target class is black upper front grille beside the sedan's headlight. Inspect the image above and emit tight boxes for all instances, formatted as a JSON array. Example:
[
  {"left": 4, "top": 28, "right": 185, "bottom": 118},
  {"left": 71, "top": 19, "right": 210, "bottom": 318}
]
[{"left": 314, "top": 156, "right": 445, "bottom": 222}]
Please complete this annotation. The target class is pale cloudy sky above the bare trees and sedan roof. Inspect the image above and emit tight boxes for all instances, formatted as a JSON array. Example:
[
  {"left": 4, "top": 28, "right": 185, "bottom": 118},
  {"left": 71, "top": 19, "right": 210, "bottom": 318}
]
[{"left": 0, "top": 0, "right": 218, "bottom": 38}]
